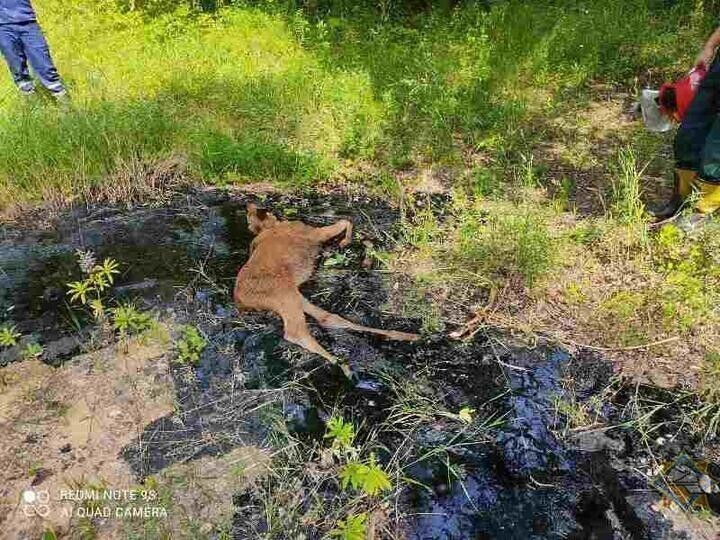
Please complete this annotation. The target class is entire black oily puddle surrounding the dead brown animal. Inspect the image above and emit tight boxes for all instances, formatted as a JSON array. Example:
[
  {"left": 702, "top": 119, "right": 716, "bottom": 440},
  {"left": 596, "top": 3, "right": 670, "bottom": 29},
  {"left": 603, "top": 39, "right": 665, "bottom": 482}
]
[{"left": 0, "top": 192, "right": 700, "bottom": 540}]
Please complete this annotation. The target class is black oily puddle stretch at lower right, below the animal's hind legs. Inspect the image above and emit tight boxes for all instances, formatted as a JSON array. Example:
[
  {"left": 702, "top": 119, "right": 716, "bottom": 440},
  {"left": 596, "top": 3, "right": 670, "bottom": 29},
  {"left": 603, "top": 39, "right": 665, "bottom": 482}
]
[{"left": 234, "top": 336, "right": 700, "bottom": 540}]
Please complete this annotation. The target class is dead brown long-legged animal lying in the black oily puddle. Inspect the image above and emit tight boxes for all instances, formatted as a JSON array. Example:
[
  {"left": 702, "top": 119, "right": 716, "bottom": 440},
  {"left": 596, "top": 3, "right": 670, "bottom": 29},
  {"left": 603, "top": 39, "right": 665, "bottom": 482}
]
[{"left": 234, "top": 203, "right": 419, "bottom": 375}]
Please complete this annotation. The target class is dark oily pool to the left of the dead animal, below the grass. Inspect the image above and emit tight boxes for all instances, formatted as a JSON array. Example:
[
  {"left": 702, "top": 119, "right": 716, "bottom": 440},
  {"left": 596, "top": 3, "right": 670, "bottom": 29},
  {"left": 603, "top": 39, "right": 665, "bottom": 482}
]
[{"left": 0, "top": 191, "right": 394, "bottom": 365}]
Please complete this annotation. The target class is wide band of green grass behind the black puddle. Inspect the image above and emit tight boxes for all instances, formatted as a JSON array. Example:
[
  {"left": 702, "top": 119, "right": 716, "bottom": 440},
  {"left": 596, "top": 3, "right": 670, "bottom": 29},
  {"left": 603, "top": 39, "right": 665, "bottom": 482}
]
[{"left": 0, "top": 0, "right": 712, "bottom": 207}]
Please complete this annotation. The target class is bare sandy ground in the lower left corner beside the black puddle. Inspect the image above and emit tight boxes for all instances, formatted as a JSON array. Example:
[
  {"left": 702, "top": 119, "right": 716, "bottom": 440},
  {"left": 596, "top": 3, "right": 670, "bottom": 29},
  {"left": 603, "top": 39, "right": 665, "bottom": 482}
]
[{"left": 0, "top": 334, "right": 265, "bottom": 540}]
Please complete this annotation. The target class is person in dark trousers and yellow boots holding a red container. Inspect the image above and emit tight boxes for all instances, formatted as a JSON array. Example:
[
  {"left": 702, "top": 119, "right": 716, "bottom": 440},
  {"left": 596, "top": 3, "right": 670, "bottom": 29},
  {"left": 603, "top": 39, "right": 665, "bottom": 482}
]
[{"left": 654, "top": 24, "right": 720, "bottom": 219}]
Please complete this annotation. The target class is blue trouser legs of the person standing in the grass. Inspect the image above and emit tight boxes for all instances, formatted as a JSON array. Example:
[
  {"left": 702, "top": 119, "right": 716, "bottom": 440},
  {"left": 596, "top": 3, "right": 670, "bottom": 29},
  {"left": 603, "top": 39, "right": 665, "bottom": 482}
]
[{"left": 0, "top": 21, "right": 65, "bottom": 95}]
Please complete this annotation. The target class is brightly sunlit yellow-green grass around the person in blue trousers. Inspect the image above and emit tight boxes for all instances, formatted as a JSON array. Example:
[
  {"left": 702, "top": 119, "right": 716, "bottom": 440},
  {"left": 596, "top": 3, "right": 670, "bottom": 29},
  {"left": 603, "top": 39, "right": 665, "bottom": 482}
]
[{"left": 0, "top": 0, "right": 381, "bottom": 205}]
